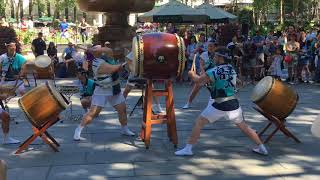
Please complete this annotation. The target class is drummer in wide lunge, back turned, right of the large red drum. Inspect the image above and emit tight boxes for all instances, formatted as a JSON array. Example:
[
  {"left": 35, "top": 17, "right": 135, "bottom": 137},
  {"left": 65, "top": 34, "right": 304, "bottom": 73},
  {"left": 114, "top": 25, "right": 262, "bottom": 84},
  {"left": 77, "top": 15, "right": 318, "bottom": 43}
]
[{"left": 175, "top": 47, "right": 268, "bottom": 156}]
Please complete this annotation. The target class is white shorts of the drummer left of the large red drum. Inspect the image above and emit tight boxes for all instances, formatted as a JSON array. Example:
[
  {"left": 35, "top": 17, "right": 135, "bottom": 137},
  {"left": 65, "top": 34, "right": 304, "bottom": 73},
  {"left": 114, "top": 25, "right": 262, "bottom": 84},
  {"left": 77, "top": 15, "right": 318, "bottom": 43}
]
[{"left": 91, "top": 92, "right": 126, "bottom": 107}]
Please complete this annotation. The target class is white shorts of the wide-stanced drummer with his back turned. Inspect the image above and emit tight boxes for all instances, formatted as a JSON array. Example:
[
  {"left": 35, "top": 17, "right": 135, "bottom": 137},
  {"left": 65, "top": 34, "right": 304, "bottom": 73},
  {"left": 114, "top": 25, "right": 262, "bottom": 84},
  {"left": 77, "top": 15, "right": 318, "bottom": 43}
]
[{"left": 200, "top": 104, "right": 244, "bottom": 124}]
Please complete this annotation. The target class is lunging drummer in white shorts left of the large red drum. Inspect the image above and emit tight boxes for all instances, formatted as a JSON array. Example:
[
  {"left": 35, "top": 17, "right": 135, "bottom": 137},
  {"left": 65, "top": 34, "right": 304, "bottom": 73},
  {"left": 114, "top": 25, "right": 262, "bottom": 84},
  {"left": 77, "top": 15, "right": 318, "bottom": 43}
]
[{"left": 73, "top": 46, "right": 135, "bottom": 141}]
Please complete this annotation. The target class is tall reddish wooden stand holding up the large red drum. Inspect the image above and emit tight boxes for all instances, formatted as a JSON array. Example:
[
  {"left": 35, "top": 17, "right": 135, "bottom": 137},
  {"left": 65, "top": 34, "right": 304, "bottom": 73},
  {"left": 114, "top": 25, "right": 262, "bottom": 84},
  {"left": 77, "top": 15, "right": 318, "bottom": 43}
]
[{"left": 140, "top": 79, "right": 178, "bottom": 149}]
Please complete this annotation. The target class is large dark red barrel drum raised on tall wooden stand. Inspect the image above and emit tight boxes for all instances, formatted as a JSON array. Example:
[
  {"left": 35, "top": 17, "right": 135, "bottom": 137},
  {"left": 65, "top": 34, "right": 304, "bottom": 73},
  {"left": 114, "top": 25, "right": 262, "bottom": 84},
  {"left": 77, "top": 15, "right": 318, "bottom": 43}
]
[{"left": 130, "top": 33, "right": 185, "bottom": 79}]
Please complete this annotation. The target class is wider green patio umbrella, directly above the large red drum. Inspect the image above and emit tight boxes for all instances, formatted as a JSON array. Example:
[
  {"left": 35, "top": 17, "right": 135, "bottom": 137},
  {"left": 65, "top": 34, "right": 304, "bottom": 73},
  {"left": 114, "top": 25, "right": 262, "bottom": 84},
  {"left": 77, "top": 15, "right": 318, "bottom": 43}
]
[{"left": 138, "top": 0, "right": 209, "bottom": 23}]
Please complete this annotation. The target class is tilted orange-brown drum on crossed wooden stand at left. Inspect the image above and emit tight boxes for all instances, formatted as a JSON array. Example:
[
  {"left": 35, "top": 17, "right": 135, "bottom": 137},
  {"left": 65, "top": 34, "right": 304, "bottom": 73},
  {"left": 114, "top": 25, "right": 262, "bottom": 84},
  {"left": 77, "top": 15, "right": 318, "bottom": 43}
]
[{"left": 18, "top": 83, "right": 69, "bottom": 127}]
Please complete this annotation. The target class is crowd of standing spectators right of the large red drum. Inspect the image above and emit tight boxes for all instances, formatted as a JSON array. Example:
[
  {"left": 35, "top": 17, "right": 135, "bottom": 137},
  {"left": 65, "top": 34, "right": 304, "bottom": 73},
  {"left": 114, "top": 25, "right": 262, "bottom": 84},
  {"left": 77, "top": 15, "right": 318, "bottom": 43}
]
[{"left": 179, "top": 26, "right": 320, "bottom": 87}]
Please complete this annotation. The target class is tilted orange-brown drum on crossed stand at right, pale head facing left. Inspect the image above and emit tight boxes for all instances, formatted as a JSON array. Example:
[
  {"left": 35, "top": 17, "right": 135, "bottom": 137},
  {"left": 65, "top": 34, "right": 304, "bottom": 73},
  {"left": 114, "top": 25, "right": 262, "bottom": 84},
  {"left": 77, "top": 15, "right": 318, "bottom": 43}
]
[{"left": 251, "top": 76, "right": 299, "bottom": 120}]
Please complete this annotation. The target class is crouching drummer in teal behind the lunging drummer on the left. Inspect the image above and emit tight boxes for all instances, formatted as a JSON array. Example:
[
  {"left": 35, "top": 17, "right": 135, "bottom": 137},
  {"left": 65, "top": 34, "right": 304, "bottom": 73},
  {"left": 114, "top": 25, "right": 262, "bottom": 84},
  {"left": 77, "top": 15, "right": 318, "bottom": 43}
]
[{"left": 77, "top": 68, "right": 95, "bottom": 112}]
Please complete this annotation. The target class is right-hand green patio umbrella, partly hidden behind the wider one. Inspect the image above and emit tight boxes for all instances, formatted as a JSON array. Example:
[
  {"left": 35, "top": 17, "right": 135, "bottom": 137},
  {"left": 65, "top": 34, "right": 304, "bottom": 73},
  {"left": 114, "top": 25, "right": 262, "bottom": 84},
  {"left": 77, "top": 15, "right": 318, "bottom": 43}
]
[{"left": 196, "top": 3, "right": 237, "bottom": 23}]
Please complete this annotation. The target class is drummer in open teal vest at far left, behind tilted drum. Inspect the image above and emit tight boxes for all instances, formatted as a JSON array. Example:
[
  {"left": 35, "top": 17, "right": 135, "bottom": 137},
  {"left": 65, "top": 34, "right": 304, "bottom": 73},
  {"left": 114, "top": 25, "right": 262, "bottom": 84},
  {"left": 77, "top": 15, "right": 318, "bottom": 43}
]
[{"left": 0, "top": 42, "right": 27, "bottom": 95}]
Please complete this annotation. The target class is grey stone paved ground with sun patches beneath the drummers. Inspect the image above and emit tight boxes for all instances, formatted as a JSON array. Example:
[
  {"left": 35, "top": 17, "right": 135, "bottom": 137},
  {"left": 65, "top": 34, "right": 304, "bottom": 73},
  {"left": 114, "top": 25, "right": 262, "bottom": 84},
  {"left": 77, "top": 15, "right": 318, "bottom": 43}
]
[{"left": 0, "top": 81, "right": 320, "bottom": 180}]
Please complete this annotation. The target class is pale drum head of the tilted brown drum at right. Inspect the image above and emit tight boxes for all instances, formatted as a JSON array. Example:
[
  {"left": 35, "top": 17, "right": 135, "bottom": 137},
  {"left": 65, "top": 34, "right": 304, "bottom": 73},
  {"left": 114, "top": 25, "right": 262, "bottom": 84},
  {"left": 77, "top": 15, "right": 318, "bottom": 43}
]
[{"left": 251, "top": 76, "right": 273, "bottom": 102}]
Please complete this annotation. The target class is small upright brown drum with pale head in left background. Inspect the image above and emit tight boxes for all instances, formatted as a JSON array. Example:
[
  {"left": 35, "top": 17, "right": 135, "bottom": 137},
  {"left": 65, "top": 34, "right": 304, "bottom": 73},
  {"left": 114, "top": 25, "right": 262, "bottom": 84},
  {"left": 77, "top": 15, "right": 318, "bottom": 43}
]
[{"left": 34, "top": 55, "right": 54, "bottom": 79}]
